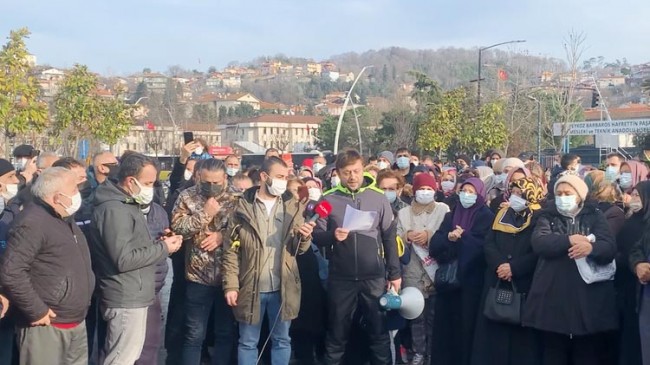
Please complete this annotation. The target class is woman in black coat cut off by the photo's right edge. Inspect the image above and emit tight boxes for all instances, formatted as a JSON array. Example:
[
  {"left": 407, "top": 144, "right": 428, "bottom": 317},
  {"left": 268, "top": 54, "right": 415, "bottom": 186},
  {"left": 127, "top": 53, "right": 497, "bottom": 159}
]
[{"left": 617, "top": 181, "right": 650, "bottom": 365}]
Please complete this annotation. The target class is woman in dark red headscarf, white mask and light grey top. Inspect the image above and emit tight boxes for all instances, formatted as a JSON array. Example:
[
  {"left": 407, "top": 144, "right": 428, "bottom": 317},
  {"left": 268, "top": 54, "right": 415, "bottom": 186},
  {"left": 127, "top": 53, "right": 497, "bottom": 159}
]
[{"left": 397, "top": 173, "right": 449, "bottom": 365}]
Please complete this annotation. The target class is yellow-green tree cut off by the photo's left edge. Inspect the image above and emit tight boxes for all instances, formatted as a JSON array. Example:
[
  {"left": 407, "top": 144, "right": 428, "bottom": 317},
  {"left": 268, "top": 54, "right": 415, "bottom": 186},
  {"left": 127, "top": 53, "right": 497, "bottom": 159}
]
[{"left": 0, "top": 28, "right": 48, "bottom": 156}]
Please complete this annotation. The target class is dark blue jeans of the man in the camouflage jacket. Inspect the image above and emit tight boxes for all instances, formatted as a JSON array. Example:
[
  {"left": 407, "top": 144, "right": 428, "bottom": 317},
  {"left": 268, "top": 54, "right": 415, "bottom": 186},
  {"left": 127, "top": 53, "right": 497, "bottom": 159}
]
[{"left": 183, "top": 281, "right": 236, "bottom": 365}]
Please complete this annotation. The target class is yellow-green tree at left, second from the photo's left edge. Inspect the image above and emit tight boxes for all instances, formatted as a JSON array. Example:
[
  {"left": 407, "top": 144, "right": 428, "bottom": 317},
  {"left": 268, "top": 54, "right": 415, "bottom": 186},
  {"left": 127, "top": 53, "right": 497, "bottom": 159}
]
[{"left": 52, "top": 65, "right": 133, "bottom": 155}]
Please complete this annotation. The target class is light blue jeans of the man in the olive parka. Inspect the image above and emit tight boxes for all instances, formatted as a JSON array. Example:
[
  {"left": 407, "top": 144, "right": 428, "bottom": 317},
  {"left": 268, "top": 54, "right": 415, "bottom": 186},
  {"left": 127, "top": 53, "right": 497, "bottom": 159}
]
[{"left": 237, "top": 291, "right": 291, "bottom": 365}]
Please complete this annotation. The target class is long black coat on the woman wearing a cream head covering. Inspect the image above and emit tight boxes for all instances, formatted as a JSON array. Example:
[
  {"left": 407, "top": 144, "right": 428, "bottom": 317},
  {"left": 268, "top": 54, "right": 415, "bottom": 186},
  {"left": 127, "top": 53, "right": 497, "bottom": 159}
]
[{"left": 523, "top": 203, "right": 618, "bottom": 336}]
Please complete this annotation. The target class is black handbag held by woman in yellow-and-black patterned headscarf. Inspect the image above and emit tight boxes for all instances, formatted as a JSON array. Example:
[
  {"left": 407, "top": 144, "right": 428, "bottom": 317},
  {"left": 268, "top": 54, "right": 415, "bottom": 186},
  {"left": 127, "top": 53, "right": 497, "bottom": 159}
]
[{"left": 483, "top": 280, "right": 524, "bottom": 325}]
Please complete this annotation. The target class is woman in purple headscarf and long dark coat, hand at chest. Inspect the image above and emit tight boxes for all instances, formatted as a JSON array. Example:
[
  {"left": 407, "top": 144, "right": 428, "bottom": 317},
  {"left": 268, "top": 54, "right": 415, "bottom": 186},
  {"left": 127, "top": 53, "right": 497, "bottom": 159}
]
[{"left": 429, "top": 177, "right": 494, "bottom": 365}]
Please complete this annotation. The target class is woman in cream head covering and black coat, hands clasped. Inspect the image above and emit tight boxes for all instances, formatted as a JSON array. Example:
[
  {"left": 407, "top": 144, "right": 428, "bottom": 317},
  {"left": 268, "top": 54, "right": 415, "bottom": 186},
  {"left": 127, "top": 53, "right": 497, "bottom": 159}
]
[{"left": 523, "top": 175, "right": 618, "bottom": 365}]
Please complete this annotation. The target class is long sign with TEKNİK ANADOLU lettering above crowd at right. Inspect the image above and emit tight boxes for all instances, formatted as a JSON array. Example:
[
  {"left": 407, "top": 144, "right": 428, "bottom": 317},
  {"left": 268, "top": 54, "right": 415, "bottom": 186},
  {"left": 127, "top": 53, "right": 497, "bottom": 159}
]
[{"left": 553, "top": 119, "right": 650, "bottom": 136}]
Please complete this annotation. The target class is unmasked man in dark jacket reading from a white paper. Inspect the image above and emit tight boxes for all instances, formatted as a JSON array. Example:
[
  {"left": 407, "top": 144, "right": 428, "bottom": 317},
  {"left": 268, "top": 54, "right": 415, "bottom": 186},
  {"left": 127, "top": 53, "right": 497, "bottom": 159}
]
[{"left": 313, "top": 150, "right": 402, "bottom": 365}]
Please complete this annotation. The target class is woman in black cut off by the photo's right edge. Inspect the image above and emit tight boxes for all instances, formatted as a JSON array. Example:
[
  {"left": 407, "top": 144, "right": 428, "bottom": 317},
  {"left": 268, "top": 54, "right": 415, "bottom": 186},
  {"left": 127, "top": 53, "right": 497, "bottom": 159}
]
[{"left": 624, "top": 181, "right": 650, "bottom": 365}]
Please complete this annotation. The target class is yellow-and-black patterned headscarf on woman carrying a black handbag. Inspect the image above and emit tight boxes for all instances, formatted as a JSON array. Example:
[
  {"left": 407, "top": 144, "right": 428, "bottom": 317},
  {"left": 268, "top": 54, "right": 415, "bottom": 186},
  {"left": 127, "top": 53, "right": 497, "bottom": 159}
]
[{"left": 492, "top": 176, "right": 544, "bottom": 233}]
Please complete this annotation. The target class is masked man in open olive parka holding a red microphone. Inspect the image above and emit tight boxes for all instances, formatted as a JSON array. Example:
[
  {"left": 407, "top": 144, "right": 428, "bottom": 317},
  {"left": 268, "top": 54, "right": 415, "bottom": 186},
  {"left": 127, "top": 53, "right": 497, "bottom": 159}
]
[{"left": 222, "top": 157, "right": 315, "bottom": 365}]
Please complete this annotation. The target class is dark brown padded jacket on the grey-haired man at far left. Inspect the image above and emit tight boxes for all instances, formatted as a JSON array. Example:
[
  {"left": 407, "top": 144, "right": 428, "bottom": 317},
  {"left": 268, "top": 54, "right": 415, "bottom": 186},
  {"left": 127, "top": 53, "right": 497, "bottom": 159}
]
[{"left": 0, "top": 199, "right": 95, "bottom": 324}]
